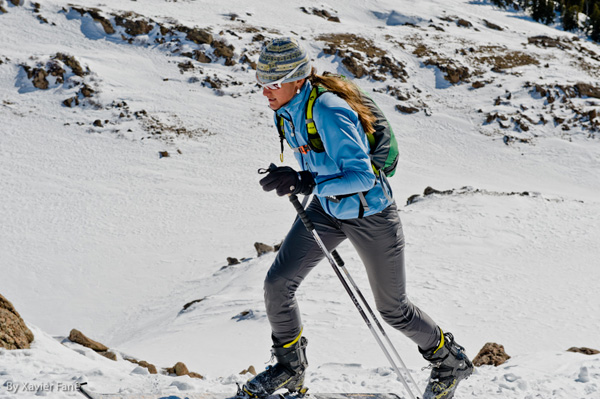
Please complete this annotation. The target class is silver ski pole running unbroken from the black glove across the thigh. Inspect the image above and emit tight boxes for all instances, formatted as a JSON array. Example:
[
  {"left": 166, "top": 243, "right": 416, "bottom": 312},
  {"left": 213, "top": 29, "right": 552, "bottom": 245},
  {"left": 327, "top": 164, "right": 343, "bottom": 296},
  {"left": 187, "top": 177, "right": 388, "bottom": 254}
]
[{"left": 290, "top": 194, "right": 419, "bottom": 399}]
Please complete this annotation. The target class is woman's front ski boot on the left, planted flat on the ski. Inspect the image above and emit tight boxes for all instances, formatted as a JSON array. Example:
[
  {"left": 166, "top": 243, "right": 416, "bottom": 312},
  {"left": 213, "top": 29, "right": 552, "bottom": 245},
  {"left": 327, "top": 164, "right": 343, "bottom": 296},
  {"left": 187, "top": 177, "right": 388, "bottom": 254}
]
[{"left": 238, "top": 337, "right": 308, "bottom": 399}]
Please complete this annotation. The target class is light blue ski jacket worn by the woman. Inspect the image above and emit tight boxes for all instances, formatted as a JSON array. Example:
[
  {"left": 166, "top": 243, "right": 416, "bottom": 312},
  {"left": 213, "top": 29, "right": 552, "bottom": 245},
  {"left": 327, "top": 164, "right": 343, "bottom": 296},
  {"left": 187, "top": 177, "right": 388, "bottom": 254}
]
[{"left": 274, "top": 80, "right": 393, "bottom": 219}]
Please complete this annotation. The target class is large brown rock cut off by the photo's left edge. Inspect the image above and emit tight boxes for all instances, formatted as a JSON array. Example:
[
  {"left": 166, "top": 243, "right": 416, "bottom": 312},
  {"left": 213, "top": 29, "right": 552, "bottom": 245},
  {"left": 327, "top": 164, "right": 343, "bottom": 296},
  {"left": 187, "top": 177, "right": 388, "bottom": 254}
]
[{"left": 0, "top": 295, "right": 34, "bottom": 350}]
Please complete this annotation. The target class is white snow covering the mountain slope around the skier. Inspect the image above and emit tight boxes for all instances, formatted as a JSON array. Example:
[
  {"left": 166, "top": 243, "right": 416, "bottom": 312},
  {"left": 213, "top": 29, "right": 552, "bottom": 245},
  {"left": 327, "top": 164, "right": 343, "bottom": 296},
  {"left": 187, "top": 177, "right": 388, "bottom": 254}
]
[{"left": 0, "top": 0, "right": 600, "bottom": 399}]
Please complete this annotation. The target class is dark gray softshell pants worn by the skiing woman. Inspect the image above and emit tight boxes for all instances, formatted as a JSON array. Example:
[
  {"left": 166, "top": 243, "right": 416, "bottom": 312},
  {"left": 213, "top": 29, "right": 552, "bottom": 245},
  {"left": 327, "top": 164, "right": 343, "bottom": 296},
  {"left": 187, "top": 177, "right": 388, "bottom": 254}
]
[{"left": 265, "top": 198, "right": 440, "bottom": 350}]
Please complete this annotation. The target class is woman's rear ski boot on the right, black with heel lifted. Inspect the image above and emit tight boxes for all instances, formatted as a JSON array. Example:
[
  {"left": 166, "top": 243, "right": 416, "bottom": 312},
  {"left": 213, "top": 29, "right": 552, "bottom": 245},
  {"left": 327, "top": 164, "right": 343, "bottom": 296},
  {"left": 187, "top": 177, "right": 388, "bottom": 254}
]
[{"left": 419, "top": 330, "right": 473, "bottom": 399}]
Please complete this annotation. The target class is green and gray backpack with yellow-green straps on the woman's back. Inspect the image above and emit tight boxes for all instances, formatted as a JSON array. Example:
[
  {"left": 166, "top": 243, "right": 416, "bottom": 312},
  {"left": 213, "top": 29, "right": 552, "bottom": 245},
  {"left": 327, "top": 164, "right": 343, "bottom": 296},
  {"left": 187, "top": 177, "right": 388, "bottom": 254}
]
[{"left": 277, "top": 86, "right": 398, "bottom": 177}]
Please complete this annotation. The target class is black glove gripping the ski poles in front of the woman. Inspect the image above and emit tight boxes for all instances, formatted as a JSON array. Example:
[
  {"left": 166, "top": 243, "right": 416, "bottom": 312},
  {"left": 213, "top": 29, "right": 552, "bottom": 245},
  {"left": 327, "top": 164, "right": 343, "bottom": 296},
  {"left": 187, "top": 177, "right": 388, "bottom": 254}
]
[{"left": 260, "top": 164, "right": 315, "bottom": 197}]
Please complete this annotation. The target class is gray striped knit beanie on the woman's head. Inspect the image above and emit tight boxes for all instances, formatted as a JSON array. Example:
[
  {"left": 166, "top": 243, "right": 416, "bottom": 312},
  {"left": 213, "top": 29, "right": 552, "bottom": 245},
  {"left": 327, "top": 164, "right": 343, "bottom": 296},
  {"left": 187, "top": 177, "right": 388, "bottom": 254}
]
[{"left": 256, "top": 37, "right": 311, "bottom": 84}]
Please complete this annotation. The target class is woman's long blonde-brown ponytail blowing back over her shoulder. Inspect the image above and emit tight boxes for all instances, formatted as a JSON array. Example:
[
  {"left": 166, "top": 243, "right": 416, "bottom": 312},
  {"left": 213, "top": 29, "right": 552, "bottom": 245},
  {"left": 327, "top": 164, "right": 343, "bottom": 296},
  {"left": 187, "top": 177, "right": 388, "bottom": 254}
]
[{"left": 307, "top": 67, "right": 377, "bottom": 134}]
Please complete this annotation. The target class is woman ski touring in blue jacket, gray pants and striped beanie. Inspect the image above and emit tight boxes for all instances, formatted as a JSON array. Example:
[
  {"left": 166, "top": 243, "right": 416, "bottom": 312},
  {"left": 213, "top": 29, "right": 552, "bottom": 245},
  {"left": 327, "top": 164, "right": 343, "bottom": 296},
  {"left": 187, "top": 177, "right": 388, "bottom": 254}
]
[{"left": 242, "top": 37, "right": 473, "bottom": 399}]
